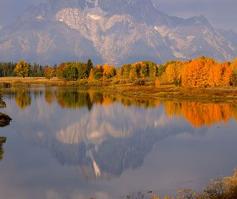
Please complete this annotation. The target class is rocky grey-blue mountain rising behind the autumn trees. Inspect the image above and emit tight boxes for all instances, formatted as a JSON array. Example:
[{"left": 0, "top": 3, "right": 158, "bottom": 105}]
[{"left": 0, "top": 0, "right": 237, "bottom": 65}]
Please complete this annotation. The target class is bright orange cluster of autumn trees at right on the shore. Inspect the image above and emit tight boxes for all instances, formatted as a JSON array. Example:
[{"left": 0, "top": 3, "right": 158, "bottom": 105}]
[{"left": 156, "top": 57, "right": 237, "bottom": 88}]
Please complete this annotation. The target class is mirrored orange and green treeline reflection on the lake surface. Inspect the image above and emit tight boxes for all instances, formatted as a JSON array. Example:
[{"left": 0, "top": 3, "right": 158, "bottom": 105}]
[{"left": 1, "top": 87, "right": 237, "bottom": 127}]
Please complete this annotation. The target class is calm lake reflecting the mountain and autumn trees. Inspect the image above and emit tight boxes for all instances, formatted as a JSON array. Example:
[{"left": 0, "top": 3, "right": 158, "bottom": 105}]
[{"left": 0, "top": 87, "right": 237, "bottom": 199}]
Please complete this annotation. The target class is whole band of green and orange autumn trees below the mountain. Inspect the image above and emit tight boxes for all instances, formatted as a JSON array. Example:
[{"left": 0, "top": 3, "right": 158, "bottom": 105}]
[{"left": 0, "top": 57, "right": 237, "bottom": 88}]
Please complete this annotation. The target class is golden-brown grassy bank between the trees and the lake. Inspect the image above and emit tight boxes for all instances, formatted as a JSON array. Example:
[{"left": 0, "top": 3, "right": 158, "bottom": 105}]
[{"left": 0, "top": 77, "right": 237, "bottom": 102}]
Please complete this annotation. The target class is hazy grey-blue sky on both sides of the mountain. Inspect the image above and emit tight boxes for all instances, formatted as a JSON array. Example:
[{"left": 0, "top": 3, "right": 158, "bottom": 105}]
[{"left": 0, "top": 0, "right": 237, "bottom": 31}]
